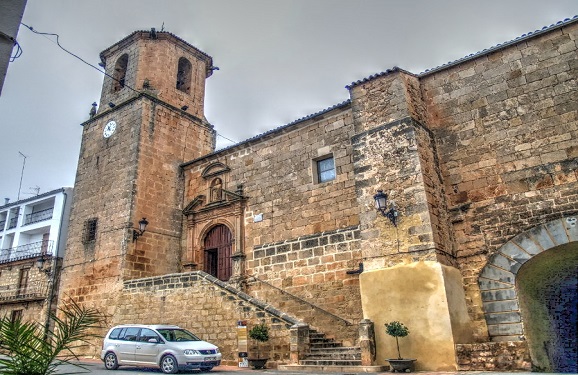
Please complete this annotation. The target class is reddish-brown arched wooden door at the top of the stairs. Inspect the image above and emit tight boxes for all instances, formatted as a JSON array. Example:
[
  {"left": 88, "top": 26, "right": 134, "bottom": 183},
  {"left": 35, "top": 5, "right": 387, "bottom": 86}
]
[{"left": 203, "top": 224, "right": 233, "bottom": 281}]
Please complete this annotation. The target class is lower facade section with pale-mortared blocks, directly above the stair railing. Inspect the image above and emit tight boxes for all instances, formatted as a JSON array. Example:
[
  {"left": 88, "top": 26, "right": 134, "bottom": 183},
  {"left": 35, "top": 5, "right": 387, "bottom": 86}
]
[{"left": 248, "top": 227, "right": 363, "bottom": 345}]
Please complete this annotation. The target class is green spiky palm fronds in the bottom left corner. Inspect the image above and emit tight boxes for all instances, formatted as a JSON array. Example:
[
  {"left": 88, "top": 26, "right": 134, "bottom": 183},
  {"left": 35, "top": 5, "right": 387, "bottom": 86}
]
[{"left": 0, "top": 300, "right": 104, "bottom": 375}]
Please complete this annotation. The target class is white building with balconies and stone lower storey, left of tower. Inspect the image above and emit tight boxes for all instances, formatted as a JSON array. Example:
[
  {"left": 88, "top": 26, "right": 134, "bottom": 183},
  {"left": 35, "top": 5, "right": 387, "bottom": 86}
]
[{"left": 0, "top": 188, "right": 73, "bottom": 321}]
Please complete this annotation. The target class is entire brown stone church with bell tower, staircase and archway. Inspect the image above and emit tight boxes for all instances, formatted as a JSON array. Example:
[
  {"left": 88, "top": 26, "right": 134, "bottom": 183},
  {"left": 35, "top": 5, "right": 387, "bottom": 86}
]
[{"left": 59, "top": 17, "right": 578, "bottom": 372}]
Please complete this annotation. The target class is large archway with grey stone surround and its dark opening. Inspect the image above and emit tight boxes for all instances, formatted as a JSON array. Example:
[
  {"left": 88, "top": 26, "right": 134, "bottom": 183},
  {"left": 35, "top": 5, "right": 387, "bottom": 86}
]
[{"left": 479, "top": 217, "right": 578, "bottom": 373}]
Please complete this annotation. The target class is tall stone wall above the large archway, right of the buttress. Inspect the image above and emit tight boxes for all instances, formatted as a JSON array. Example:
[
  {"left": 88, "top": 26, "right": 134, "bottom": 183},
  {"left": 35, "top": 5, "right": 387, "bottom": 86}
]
[{"left": 420, "top": 23, "right": 578, "bottom": 341}]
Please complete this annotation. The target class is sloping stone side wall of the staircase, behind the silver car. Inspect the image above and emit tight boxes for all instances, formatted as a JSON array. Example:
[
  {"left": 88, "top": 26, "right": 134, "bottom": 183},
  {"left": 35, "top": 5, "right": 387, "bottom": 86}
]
[{"left": 113, "top": 271, "right": 297, "bottom": 368}]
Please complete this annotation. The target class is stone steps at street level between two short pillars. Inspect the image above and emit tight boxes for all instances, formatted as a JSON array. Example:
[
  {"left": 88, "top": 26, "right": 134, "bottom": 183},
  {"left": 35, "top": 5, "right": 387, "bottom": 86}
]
[{"left": 277, "top": 330, "right": 389, "bottom": 373}]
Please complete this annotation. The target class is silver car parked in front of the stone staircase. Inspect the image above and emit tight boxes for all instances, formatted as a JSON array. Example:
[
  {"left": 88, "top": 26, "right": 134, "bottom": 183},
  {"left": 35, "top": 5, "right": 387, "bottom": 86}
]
[{"left": 100, "top": 324, "right": 221, "bottom": 374}]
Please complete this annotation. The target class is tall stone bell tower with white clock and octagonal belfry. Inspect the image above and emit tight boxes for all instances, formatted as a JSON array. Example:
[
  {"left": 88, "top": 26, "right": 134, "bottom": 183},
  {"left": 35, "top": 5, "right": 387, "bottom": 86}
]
[{"left": 60, "top": 29, "right": 215, "bottom": 322}]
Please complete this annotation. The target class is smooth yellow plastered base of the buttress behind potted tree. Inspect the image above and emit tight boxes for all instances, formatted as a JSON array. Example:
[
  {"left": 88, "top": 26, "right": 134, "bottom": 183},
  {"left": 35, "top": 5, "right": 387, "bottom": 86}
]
[{"left": 360, "top": 261, "right": 470, "bottom": 371}]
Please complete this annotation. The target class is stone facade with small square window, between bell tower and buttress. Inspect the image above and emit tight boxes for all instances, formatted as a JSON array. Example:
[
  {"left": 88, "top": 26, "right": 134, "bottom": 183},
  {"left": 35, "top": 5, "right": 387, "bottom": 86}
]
[{"left": 182, "top": 103, "right": 362, "bottom": 342}]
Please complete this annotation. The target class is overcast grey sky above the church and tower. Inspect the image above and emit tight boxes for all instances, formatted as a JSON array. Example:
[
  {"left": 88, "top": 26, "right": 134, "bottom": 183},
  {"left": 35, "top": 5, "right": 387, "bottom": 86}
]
[{"left": 0, "top": 0, "right": 578, "bottom": 205}]
